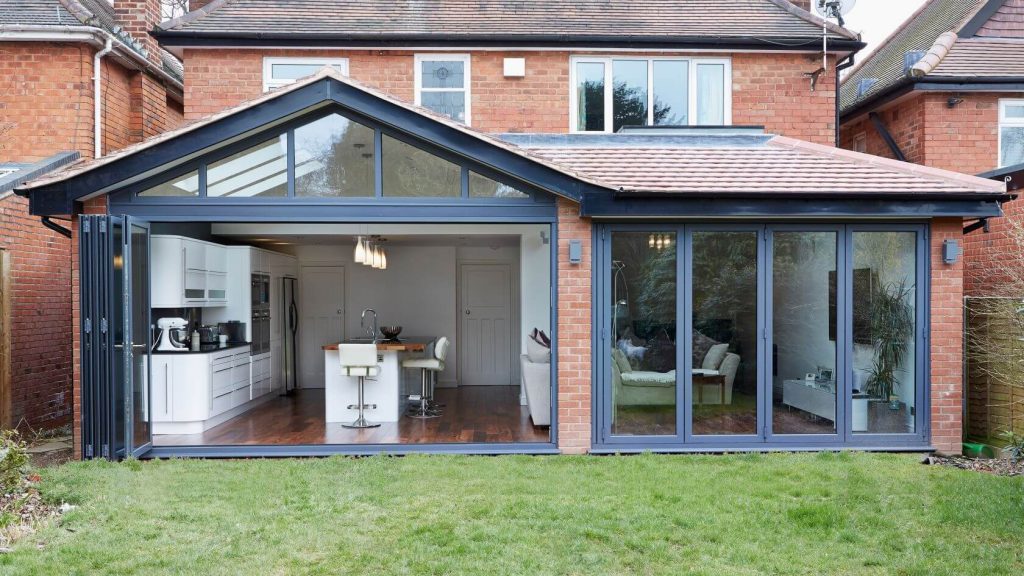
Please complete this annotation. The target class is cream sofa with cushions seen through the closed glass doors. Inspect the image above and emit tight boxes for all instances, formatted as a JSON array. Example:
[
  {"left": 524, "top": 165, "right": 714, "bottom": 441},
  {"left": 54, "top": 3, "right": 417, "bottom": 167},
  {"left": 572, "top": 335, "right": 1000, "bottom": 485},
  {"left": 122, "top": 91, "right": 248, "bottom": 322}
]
[{"left": 611, "top": 343, "right": 740, "bottom": 406}]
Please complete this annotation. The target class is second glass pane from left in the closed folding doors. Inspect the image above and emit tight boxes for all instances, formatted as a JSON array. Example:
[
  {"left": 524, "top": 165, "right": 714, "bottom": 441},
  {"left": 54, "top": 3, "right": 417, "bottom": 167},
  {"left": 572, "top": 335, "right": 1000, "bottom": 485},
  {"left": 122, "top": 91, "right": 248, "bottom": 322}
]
[{"left": 689, "top": 231, "right": 761, "bottom": 436}]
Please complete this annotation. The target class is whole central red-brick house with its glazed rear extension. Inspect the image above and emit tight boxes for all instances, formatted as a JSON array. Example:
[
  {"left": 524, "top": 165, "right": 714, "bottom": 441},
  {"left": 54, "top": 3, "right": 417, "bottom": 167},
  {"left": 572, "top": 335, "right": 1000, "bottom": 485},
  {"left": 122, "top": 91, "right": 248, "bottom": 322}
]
[{"left": 18, "top": 0, "right": 1007, "bottom": 458}]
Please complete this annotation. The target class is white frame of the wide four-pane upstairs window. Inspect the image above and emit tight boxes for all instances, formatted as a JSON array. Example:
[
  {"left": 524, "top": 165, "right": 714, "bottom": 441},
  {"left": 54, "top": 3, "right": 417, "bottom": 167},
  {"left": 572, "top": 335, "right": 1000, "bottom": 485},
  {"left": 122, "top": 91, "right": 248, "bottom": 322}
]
[{"left": 569, "top": 54, "right": 732, "bottom": 134}]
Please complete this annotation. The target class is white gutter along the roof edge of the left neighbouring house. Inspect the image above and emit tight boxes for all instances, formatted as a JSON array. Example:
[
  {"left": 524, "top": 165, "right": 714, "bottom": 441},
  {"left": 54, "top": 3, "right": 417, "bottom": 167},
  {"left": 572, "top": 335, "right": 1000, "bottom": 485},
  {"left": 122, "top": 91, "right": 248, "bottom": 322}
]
[{"left": 0, "top": 25, "right": 184, "bottom": 101}]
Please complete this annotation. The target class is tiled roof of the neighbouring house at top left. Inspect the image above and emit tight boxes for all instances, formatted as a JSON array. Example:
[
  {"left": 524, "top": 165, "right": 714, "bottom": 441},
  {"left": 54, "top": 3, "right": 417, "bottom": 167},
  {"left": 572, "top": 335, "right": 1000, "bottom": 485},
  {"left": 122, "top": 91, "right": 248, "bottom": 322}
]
[{"left": 0, "top": 0, "right": 184, "bottom": 82}]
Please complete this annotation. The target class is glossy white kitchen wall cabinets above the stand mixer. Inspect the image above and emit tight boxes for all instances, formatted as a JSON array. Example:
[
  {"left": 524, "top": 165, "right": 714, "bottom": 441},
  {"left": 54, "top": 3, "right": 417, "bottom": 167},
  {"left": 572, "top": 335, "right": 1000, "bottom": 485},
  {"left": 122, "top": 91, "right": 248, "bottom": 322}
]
[{"left": 150, "top": 235, "right": 228, "bottom": 308}]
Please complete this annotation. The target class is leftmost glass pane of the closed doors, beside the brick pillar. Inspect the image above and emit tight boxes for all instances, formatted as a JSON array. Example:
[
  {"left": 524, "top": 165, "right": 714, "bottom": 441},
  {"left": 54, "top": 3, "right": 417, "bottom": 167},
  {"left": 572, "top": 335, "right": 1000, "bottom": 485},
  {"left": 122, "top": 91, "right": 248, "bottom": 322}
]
[{"left": 609, "top": 231, "right": 678, "bottom": 437}]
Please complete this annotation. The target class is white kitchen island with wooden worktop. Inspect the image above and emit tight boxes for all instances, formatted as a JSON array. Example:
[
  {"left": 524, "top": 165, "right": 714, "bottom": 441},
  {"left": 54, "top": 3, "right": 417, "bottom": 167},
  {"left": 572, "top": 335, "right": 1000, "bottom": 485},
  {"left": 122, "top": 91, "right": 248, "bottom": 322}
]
[{"left": 324, "top": 337, "right": 432, "bottom": 423}]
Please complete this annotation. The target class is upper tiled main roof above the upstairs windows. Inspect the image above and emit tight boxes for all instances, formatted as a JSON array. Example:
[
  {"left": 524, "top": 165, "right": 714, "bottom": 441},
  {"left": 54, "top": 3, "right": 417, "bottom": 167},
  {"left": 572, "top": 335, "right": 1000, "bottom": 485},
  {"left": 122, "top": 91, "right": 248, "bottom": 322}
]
[{"left": 161, "top": 0, "right": 857, "bottom": 41}]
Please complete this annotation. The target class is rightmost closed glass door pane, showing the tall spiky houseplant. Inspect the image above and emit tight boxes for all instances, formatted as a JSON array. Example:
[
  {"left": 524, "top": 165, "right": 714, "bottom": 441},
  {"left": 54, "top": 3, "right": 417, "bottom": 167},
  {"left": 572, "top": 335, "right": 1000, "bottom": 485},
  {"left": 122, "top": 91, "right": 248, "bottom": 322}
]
[{"left": 851, "top": 231, "right": 920, "bottom": 435}]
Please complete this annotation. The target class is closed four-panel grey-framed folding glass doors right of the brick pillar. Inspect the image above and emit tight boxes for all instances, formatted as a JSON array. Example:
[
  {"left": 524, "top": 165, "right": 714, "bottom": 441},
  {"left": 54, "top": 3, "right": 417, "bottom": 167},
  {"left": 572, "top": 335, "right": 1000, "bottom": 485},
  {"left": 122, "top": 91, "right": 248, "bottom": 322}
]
[{"left": 596, "top": 223, "right": 927, "bottom": 447}]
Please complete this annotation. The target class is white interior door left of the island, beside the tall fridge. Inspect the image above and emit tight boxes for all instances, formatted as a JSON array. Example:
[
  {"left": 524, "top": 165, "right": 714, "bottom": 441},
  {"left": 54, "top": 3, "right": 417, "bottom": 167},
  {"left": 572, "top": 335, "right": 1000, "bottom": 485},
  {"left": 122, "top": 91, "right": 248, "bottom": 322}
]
[{"left": 298, "top": 266, "right": 345, "bottom": 388}]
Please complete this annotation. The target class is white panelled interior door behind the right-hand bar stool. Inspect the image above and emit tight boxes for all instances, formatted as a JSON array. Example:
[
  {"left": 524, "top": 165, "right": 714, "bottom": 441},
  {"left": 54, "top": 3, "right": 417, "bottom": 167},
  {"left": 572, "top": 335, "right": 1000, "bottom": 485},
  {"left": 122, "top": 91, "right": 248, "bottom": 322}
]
[{"left": 459, "top": 264, "right": 512, "bottom": 386}]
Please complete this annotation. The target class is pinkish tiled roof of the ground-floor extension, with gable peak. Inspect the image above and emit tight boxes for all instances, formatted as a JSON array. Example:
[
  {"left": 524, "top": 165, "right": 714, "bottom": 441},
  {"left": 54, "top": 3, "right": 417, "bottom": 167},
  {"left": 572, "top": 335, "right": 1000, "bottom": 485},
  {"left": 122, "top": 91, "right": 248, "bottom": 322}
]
[{"left": 22, "top": 68, "right": 1005, "bottom": 199}]
